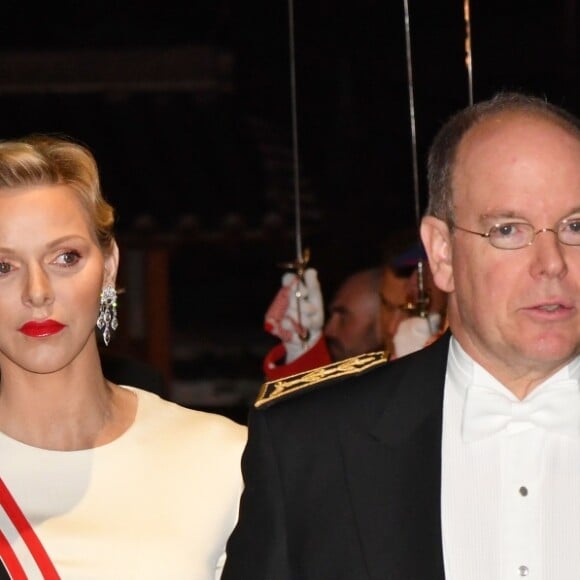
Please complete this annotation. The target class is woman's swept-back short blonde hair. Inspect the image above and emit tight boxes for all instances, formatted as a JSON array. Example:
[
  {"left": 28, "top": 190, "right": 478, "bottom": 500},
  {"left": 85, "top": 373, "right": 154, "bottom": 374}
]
[{"left": 0, "top": 134, "right": 115, "bottom": 254}]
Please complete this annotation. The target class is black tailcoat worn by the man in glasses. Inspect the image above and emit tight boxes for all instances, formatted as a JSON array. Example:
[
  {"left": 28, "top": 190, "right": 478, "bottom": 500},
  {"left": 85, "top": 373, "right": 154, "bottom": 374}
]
[{"left": 222, "top": 334, "right": 449, "bottom": 580}]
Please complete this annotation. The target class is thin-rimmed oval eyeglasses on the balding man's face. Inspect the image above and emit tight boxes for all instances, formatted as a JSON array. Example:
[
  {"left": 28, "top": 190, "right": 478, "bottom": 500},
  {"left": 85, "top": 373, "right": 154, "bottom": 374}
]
[{"left": 451, "top": 216, "right": 580, "bottom": 250}]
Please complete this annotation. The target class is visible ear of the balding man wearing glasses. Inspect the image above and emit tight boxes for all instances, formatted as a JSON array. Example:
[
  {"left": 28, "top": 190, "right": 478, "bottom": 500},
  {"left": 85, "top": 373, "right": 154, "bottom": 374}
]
[{"left": 421, "top": 216, "right": 455, "bottom": 292}]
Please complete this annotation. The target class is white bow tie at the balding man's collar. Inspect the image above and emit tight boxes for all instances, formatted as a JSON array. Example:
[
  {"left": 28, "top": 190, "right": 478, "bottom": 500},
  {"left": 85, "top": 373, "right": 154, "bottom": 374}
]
[{"left": 462, "top": 380, "right": 580, "bottom": 442}]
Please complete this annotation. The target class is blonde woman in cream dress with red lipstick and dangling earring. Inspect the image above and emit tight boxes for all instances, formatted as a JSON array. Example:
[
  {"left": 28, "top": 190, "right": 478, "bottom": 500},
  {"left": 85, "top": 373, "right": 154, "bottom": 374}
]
[{"left": 0, "top": 136, "right": 246, "bottom": 580}]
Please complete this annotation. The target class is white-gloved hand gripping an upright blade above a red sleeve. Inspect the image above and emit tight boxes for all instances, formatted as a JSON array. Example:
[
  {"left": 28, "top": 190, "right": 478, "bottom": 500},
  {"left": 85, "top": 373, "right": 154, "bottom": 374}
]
[{"left": 264, "top": 268, "right": 324, "bottom": 363}]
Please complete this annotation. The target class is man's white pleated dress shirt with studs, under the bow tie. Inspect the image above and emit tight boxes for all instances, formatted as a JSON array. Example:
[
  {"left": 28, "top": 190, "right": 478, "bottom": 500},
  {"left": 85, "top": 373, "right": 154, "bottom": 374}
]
[{"left": 441, "top": 339, "right": 580, "bottom": 580}]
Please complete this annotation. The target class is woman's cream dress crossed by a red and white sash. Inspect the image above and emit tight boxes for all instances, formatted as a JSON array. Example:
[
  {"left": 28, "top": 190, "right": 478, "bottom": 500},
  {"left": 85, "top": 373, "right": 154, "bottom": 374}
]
[{"left": 0, "top": 387, "right": 246, "bottom": 580}]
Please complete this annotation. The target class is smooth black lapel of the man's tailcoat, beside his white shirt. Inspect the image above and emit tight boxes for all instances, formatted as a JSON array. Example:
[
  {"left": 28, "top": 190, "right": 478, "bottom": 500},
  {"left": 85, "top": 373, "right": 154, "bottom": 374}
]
[{"left": 342, "top": 335, "right": 449, "bottom": 580}]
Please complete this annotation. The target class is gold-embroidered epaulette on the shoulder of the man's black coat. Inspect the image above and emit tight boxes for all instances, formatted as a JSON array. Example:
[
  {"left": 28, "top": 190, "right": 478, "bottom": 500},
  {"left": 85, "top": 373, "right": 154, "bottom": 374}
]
[{"left": 254, "top": 351, "right": 389, "bottom": 409}]
